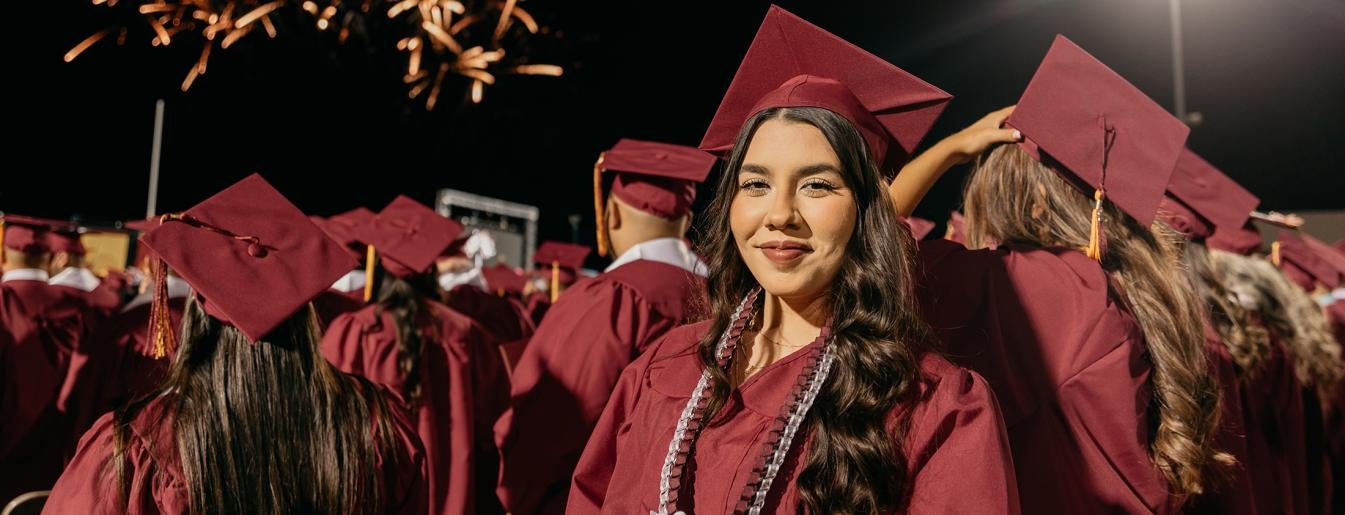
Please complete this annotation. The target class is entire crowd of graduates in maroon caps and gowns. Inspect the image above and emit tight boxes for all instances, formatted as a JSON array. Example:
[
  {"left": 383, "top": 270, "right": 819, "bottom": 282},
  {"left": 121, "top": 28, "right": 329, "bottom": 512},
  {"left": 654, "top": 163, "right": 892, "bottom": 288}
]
[{"left": 0, "top": 8, "right": 1345, "bottom": 515}]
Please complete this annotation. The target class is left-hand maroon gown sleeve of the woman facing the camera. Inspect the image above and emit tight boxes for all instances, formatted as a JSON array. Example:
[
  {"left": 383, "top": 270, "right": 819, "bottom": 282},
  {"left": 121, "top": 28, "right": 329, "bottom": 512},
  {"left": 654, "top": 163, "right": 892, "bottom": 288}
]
[{"left": 565, "top": 331, "right": 669, "bottom": 515}]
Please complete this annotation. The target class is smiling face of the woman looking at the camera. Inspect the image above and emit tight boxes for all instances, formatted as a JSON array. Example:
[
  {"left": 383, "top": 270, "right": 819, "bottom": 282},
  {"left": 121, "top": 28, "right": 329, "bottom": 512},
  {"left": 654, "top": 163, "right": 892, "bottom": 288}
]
[{"left": 729, "top": 118, "right": 858, "bottom": 300}]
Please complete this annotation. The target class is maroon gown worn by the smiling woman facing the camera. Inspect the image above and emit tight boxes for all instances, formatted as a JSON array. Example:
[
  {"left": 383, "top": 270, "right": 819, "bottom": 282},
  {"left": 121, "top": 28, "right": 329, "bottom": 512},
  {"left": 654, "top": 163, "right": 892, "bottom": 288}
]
[{"left": 568, "top": 323, "right": 1018, "bottom": 515}]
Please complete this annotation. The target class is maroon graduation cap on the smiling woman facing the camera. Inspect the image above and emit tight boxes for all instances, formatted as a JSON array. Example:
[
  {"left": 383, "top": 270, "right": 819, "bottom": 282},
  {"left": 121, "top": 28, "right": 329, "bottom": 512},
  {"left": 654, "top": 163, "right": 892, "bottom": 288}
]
[{"left": 701, "top": 5, "right": 952, "bottom": 172}]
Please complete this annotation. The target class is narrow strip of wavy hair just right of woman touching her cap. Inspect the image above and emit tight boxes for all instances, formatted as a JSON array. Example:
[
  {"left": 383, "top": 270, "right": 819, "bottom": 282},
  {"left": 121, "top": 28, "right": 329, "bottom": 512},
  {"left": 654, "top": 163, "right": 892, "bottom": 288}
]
[{"left": 1182, "top": 242, "right": 1271, "bottom": 379}]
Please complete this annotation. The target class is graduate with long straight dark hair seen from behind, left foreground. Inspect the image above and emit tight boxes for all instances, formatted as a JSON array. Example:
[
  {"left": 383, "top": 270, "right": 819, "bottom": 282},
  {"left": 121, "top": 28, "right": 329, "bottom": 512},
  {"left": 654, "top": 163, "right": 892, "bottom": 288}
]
[{"left": 44, "top": 175, "right": 425, "bottom": 514}]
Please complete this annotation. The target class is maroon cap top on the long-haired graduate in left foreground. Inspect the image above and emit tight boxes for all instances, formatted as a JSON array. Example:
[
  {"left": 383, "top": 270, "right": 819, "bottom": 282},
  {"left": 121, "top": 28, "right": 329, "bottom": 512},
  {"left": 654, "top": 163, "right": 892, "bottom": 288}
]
[{"left": 140, "top": 173, "right": 356, "bottom": 342}]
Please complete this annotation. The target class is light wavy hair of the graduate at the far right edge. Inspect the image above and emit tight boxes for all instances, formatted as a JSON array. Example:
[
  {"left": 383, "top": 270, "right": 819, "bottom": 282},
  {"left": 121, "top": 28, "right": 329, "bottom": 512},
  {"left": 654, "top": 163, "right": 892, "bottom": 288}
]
[{"left": 1212, "top": 250, "right": 1345, "bottom": 401}]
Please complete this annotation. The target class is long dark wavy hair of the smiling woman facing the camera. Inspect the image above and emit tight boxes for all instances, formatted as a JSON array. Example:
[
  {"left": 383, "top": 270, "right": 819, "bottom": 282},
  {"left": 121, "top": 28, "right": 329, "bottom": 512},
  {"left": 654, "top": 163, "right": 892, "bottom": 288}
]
[{"left": 699, "top": 108, "right": 931, "bottom": 514}]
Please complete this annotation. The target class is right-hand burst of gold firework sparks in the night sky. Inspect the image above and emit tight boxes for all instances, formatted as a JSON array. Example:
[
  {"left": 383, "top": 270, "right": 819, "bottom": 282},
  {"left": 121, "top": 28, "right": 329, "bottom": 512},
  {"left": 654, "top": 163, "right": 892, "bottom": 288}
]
[{"left": 387, "top": 0, "right": 565, "bottom": 109}]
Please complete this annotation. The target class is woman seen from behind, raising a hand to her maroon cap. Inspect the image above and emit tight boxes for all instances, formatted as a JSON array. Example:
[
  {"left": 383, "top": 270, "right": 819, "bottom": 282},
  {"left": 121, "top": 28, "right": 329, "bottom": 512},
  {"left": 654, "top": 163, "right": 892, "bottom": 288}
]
[{"left": 892, "top": 36, "right": 1229, "bottom": 514}]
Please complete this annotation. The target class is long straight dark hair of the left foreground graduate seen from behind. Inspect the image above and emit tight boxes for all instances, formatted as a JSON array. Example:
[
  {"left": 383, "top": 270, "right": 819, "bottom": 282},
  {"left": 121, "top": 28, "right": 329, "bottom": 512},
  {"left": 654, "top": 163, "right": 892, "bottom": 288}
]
[{"left": 112, "top": 300, "right": 406, "bottom": 514}]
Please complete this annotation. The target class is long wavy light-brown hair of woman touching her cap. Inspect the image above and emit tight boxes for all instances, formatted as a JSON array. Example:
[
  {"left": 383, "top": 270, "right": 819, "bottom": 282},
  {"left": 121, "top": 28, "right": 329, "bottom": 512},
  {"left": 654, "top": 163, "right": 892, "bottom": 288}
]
[{"left": 964, "top": 144, "right": 1232, "bottom": 506}]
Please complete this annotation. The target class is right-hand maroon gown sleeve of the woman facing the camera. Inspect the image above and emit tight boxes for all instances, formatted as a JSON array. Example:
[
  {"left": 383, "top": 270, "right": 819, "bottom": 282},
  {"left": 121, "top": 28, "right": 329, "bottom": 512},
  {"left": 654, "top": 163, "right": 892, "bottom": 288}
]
[{"left": 905, "top": 356, "right": 1018, "bottom": 515}]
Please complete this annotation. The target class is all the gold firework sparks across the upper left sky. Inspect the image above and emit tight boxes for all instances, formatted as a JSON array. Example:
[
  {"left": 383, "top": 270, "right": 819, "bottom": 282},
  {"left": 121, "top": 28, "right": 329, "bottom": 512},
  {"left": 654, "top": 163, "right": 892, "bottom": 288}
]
[{"left": 65, "top": 0, "right": 565, "bottom": 109}]
